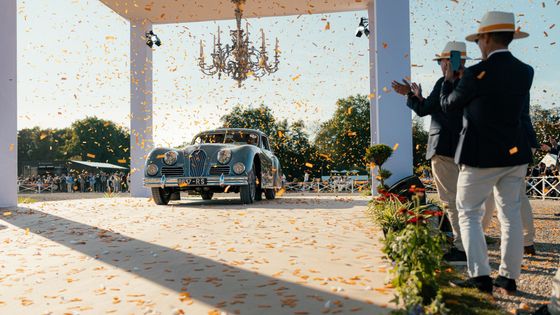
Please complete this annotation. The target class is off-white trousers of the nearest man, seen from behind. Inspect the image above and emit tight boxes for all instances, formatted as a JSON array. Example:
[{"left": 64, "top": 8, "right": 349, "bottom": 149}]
[{"left": 457, "top": 164, "right": 527, "bottom": 279}]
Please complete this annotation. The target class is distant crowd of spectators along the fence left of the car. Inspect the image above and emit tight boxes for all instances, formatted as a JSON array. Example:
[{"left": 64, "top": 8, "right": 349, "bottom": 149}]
[{"left": 18, "top": 172, "right": 130, "bottom": 193}]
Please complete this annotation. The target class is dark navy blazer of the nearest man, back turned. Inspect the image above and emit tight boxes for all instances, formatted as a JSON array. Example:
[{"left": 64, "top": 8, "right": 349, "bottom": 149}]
[{"left": 441, "top": 52, "right": 538, "bottom": 168}]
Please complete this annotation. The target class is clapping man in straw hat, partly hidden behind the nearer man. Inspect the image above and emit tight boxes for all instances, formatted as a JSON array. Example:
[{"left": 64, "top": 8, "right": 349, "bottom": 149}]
[{"left": 392, "top": 41, "right": 469, "bottom": 264}]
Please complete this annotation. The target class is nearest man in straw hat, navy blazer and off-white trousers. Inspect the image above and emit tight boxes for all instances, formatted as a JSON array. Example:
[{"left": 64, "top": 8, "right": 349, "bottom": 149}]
[{"left": 441, "top": 12, "right": 534, "bottom": 293}]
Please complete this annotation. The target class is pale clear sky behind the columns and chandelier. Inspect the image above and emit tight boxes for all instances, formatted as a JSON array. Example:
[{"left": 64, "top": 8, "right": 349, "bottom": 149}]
[{"left": 18, "top": 0, "right": 560, "bottom": 146}]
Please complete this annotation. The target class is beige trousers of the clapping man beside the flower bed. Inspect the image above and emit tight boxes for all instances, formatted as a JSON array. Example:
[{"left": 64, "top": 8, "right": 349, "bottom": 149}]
[{"left": 432, "top": 155, "right": 464, "bottom": 251}]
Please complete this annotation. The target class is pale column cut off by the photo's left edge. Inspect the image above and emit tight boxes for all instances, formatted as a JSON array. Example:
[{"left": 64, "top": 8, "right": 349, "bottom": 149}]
[{"left": 0, "top": 0, "right": 18, "bottom": 208}]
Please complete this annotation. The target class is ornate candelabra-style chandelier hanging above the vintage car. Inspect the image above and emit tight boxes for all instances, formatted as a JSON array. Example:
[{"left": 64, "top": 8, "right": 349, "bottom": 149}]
[{"left": 198, "top": 0, "right": 280, "bottom": 87}]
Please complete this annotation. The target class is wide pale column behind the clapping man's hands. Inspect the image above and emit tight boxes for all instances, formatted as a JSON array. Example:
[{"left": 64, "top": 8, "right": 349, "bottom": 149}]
[{"left": 368, "top": 0, "right": 413, "bottom": 186}]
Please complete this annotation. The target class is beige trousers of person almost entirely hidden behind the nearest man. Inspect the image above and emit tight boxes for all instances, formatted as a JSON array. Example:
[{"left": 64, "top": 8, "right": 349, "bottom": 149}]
[{"left": 482, "top": 179, "right": 535, "bottom": 246}]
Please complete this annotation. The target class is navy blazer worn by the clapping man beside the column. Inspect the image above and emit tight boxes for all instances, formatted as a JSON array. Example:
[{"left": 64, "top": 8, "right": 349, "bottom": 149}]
[{"left": 406, "top": 77, "right": 463, "bottom": 160}]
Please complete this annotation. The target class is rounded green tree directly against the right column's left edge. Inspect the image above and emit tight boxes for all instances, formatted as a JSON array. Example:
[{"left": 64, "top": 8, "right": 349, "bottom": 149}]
[{"left": 315, "top": 95, "right": 370, "bottom": 173}]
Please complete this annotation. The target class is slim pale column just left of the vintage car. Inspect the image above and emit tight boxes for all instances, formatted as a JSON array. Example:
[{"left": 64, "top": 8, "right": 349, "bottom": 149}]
[{"left": 130, "top": 20, "right": 153, "bottom": 197}]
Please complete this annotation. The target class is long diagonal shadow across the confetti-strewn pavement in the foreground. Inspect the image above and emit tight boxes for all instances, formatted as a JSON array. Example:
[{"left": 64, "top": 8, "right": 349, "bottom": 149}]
[{"left": 0, "top": 204, "right": 390, "bottom": 314}]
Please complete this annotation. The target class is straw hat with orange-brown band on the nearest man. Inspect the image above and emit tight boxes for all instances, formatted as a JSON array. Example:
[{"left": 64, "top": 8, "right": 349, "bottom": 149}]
[{"left": 466, "top": 11, "right": 529, "bottom": 42}]
